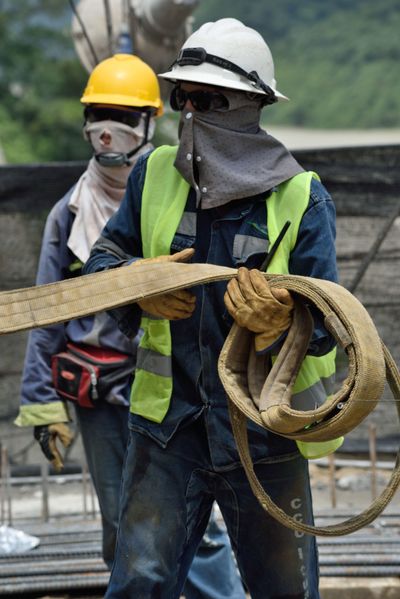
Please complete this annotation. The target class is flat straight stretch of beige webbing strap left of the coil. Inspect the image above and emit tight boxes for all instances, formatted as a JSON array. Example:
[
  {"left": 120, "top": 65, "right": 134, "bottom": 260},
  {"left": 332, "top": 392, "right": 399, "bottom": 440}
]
[{"left": 0, "top": 260, "right": 236, "bottom": 335}]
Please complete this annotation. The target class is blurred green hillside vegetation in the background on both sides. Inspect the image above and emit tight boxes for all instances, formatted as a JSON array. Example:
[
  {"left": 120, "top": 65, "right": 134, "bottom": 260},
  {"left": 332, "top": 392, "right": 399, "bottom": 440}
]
[{"left": 0, "top": 0, "right": 400, "bottom": 162}]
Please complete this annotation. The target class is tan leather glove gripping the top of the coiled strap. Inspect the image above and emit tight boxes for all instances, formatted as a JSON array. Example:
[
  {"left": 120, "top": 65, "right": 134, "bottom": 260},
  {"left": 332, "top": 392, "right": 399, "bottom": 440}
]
[{"left": 224, "top": 267, "right": 293, "bottom": 351}]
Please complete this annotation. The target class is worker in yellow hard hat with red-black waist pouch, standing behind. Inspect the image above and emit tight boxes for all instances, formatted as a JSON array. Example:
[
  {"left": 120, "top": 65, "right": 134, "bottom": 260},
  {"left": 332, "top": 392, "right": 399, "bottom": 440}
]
[{"left": 16, "top": 54, "right": 244, "bottom": 599}]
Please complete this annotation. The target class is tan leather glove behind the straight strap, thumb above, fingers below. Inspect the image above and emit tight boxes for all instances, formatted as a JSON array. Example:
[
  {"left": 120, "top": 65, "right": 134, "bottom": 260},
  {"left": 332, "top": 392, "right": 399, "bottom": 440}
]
[{"left": 135, "top": 248, "right": 196, "bottom": 320}]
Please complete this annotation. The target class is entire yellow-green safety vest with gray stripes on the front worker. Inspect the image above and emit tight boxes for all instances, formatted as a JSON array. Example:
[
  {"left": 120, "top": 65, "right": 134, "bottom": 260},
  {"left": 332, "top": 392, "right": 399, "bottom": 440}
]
[{"left": 130, "top": 146, "right": 340, "bottom": 457}]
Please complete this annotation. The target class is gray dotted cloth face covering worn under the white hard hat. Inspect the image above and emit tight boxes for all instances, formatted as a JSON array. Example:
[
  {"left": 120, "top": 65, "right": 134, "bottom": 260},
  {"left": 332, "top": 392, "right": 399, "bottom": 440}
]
[{"left": 175, "top": 90, "right": 303, "bottom": 209}]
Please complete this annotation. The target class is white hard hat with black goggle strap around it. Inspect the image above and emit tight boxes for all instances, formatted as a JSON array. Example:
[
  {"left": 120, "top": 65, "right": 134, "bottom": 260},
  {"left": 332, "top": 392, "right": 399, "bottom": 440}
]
[{"left": 159, "top": 18, "right": 288, "bottom": 104}]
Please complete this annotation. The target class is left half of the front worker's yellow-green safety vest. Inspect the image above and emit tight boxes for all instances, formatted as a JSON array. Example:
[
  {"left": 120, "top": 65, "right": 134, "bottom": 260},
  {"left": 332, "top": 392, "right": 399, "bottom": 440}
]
[{"left": 130, "top": 146, "right": 189, "bottom": 422}]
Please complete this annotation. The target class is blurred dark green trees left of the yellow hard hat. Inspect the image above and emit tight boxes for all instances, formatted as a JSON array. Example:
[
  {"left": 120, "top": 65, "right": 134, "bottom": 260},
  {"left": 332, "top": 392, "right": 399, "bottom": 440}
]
[{"left": 0, "top": 0, "right": 89, "bottom": 162}]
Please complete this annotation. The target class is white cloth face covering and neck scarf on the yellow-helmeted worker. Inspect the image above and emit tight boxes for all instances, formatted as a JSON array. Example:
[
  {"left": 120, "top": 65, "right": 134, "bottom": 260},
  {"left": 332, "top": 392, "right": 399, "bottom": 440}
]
[{"left": 67, "top": 117, "right": 155, "bottom": 262}]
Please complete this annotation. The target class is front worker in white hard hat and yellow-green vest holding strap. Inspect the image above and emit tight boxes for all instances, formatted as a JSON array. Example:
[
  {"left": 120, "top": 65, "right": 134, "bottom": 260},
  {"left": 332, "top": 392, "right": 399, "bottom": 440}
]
[{"left": 83, "top": 18, "right": 337, "bottom": 599}]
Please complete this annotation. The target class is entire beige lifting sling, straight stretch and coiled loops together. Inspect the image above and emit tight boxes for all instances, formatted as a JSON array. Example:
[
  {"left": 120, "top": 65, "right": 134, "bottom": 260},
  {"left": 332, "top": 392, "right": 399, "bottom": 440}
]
[{"left": 0, "top": 260, "right": 400, "bottom": 536}]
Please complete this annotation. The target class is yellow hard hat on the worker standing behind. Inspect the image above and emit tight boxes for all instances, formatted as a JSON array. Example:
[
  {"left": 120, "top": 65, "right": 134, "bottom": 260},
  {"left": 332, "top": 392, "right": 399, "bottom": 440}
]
[{"left": 81, "top": 54, "right": 163, "bottom": 116}]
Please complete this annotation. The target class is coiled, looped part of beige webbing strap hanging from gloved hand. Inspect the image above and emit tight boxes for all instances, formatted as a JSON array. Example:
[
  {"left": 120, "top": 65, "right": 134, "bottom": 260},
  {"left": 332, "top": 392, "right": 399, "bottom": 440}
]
[{"left": 219, "top": 275, "right": 400, "bottom": 536}]
